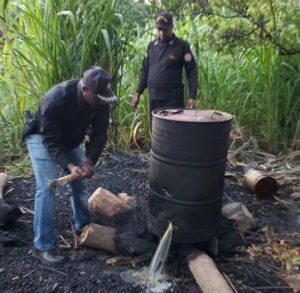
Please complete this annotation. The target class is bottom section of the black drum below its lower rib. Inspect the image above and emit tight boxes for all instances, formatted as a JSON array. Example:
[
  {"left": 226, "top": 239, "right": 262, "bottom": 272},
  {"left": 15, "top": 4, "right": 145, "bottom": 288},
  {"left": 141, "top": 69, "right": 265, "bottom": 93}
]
[{"left": 147, "top": 190, "right": 222, "bottom": 244}]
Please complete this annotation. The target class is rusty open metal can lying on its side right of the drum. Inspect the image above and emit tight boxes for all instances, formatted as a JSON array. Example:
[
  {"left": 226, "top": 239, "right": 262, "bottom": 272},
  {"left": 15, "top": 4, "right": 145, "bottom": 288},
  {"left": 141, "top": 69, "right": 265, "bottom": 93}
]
[{"left": 243, "top": 169, "right": 278, "bottom": 197}]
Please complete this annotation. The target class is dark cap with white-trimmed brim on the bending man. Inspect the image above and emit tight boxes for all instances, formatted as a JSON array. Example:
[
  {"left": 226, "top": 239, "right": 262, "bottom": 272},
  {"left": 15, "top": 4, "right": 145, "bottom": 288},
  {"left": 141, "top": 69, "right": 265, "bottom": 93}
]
[{"left": 82, "top": 66, "right": 117, "bottom": 103}]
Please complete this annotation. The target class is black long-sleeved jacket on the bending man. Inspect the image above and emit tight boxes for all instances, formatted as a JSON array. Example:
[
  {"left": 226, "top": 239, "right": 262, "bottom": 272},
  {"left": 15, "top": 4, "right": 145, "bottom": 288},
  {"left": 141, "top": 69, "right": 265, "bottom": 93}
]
[{"left": 30, "top": 80, "right": 109, "bottom": 168}]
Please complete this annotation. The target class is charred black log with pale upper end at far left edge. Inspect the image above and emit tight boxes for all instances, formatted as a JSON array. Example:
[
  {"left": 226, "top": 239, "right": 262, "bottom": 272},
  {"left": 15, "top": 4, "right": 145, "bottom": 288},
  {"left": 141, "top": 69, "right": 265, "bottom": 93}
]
[{"left": 0, "top": 173, "right": 22, "bottom": 226}]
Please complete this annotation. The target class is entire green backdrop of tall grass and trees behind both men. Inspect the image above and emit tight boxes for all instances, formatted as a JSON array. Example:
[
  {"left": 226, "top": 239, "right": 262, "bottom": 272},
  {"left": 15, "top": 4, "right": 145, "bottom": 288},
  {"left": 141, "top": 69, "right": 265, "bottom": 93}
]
[{"left": 0, "top": 0, "right": 300, "bottom": 169}]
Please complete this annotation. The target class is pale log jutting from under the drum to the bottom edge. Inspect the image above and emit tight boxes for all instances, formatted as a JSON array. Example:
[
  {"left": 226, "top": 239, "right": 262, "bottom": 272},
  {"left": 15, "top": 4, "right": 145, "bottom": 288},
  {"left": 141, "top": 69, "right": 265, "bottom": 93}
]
[{"left": 189, "top": 252, "right": 233, "bottom": 293}]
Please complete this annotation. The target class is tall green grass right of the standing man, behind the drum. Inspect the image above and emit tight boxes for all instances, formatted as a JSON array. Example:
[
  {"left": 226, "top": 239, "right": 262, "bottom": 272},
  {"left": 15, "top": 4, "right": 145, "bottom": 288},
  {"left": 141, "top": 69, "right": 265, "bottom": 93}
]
[{"left": 178, "top": 13, "right": 300, "bottom": 153}]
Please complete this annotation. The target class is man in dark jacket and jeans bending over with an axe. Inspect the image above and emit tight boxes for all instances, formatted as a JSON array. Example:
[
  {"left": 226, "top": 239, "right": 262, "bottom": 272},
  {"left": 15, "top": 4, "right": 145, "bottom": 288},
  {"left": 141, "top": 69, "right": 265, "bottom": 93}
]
[{"left": 24, "top": 66, "right": 116, "bottom": 265}]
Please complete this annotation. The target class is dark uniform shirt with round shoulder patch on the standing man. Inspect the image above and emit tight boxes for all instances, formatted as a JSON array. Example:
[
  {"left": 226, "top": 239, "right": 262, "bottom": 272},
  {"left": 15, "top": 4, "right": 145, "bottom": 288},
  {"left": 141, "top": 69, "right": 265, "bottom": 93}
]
[{"left": 137, "top": 35, "right": 198, "bottom": 100}]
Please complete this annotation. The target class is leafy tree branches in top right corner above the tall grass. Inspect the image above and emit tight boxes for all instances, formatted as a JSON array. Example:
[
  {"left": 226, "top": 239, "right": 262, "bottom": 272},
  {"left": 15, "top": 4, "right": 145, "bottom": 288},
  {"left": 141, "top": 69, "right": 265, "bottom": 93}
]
[{"left": 190, "top": 0, "right": 300, "bottom": 55}]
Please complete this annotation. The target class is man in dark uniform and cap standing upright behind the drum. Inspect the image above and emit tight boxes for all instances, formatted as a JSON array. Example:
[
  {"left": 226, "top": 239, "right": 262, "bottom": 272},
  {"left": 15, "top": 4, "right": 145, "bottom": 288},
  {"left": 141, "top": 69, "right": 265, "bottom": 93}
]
[{"left": 131, "top": 12, "right": 197, "bottom": 115}]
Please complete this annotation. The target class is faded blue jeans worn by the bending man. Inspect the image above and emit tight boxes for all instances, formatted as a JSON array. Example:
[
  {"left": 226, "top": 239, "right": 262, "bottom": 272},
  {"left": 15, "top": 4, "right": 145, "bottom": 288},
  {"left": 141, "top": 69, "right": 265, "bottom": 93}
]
[{"left": 26, "top": 134, "right": 90, "bottom": 251}]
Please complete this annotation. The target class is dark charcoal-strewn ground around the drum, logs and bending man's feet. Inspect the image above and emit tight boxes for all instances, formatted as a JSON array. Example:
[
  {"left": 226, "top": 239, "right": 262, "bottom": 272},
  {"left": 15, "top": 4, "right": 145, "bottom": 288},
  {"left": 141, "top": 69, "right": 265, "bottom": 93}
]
[{"left": 0, "top": 152, "right": 300, "bottom": 293}]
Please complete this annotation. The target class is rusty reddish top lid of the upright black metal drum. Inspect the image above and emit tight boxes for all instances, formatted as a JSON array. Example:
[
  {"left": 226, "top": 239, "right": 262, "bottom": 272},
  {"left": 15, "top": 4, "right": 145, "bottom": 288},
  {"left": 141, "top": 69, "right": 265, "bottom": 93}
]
[{"left": 152, "top": 108, "right": 232, "bottom": 122}]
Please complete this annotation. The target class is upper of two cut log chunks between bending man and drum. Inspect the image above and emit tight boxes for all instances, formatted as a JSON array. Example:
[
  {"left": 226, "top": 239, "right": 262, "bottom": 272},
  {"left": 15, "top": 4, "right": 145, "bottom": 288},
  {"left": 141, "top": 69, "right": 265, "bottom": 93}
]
[{"left": 89, "top": 187, "right": 132, "bottom": 218}]
